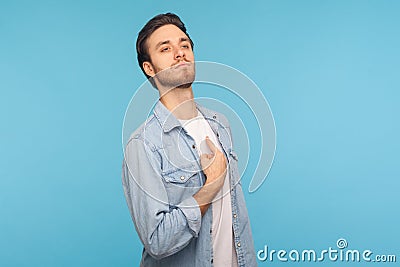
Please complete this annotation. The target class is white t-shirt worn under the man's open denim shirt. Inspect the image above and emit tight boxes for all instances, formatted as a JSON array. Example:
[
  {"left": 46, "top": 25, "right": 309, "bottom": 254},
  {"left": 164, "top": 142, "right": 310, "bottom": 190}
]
[{"left": 179, "top": 112, "right": 238, "bottom": 267}]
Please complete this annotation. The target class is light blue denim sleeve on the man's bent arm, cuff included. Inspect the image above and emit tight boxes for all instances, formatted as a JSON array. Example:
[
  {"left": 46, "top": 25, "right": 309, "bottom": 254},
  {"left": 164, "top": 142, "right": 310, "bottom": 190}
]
[{"left": 122, "top": 138, "right": 201, "bottom": 259}]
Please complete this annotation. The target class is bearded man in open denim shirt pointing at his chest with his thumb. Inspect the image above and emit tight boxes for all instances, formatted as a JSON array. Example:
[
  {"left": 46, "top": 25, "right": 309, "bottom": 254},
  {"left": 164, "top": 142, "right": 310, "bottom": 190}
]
[{"left": 122, "top": 13, "right": 257, "bottom": 267}]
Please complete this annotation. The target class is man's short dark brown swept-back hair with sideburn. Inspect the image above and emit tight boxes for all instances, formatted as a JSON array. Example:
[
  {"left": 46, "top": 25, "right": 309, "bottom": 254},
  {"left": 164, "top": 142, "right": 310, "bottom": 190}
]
[{"left": 136, "top": 13, "right": 194, "bottom": 87}]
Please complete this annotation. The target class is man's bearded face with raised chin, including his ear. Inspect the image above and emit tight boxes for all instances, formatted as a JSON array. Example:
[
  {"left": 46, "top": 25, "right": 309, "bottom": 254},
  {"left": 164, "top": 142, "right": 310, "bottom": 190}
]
[{"left": 143, "top": 24, "right": 195, "bottom": 89}]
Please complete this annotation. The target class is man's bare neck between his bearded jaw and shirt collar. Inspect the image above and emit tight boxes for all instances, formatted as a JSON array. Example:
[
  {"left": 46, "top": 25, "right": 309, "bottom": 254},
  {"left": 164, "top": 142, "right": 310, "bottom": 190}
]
[{"left": 160, "top": 86, "right": 197, "bottom": 120}]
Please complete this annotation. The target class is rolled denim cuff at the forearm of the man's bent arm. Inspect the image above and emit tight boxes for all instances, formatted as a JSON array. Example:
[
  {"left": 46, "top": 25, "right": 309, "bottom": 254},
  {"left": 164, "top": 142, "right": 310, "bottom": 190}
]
[{"left": 178, "top": 197, "right": 201, "bottom": 237}]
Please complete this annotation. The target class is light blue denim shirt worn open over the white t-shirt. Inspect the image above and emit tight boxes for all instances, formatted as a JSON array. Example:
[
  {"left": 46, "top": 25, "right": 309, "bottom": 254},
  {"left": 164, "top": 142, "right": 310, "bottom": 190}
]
[{"left": 122, "top": 102, "right": 257, "bottom": 267}]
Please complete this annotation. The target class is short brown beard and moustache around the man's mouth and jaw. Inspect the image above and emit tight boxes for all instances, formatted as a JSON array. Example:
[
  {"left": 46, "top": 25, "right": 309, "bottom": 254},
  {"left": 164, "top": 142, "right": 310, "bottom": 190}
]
[{"left": 153, "top": 62, "right": 196, "bottom": 90}]
